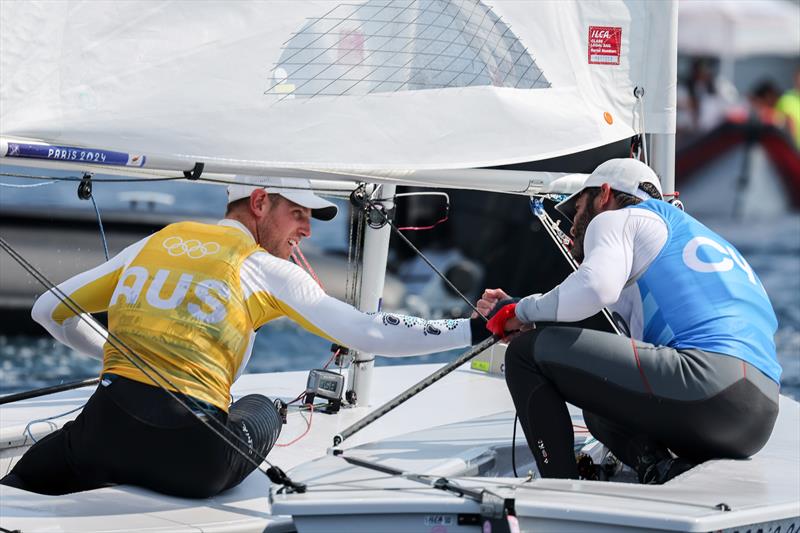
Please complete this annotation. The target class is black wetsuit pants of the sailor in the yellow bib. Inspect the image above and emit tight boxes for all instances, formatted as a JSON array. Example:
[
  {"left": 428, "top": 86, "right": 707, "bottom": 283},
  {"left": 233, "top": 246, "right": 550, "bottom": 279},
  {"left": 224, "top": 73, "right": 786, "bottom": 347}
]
[{"left": 0, "top": 376, "right": 281, "bottom": 498}]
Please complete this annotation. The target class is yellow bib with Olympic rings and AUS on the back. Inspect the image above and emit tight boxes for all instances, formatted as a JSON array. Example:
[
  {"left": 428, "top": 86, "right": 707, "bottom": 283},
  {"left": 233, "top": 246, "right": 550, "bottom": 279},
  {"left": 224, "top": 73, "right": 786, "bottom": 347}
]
[{"left": 103, "top": 222, "right": 258, "bottom": 411}]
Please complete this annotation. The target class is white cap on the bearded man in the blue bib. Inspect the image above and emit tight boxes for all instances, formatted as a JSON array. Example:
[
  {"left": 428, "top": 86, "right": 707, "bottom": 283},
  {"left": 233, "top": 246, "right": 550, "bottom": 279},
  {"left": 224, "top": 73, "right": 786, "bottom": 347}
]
[{"left": 556, "top": 158, "right": 663, "bottom": 220}]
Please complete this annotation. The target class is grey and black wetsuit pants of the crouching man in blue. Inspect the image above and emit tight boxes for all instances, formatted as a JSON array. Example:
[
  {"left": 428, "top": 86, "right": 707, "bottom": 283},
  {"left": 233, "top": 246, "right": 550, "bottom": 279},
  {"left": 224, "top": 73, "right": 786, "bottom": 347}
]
[{"left": 505, "top": 326, "right": 779, "bottom": 478}]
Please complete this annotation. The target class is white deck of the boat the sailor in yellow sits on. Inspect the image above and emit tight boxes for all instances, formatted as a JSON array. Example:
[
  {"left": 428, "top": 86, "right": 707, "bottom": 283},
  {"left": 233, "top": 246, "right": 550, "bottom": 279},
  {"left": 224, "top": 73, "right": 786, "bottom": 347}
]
[{"left": 0, "top": 365, "right": 511, "bottom": 533}]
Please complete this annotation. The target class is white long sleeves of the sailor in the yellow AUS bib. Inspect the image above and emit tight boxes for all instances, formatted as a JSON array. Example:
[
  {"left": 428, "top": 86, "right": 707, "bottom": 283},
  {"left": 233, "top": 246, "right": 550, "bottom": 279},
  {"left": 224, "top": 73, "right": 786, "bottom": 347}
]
[{"left": 32, "top": 219, "right": 470, "bottom": 375}]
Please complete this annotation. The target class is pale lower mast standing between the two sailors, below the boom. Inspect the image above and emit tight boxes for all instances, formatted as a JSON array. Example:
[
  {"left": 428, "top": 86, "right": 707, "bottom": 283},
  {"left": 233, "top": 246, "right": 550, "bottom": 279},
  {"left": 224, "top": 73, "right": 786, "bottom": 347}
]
[{"left": 347, "top": 185, "right": 397, "bottom": 406}]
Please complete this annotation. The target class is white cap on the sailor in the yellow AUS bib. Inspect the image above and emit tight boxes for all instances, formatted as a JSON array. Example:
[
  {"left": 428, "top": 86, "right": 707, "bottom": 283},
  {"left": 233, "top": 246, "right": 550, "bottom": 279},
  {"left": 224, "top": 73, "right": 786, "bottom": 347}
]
[{"left": 228, "top": 175, "right": 339, "bottom": 220}]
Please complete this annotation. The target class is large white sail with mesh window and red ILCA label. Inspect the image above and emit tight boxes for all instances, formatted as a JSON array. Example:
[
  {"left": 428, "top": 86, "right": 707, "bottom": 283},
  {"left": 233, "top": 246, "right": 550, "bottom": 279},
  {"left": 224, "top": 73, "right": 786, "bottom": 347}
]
[{"left": 0, "top": 0, "right": 677, "bottom": 181}]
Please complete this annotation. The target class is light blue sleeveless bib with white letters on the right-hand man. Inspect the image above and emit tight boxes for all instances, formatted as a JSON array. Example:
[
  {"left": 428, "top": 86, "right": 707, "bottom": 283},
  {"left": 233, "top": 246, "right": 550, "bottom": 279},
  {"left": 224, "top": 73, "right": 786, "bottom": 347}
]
[{"left": 630, "top": 200, "right": 781, "bottom": 383}]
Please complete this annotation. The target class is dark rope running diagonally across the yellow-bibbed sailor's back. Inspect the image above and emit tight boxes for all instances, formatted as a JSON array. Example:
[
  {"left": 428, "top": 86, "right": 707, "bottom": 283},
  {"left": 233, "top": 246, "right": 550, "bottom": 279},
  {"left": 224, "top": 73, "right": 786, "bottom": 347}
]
[{"left": 0, "top": 237, "right": 305, "bottom": 492}]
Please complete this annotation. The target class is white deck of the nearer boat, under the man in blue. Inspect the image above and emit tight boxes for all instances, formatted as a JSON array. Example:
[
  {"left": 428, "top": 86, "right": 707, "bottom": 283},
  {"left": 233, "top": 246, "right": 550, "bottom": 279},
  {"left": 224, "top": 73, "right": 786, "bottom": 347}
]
[{"left": 273, "top": 397, "right": 800, "bottom": 533}]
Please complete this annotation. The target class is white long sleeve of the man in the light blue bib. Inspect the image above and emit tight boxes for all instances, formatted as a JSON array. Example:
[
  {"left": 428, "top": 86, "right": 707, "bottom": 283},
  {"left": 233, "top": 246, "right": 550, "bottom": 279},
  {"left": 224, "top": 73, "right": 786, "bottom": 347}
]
[{"left": 516, "top": 209, "right": 668, "bottom": 337}]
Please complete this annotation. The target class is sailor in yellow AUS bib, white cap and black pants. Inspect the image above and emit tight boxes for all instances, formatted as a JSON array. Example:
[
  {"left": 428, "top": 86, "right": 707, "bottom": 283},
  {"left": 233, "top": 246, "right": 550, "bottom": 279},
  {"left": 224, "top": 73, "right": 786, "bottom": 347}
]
[{"left": 0, "top": 176, "right": 483, "bottom": 497}]
